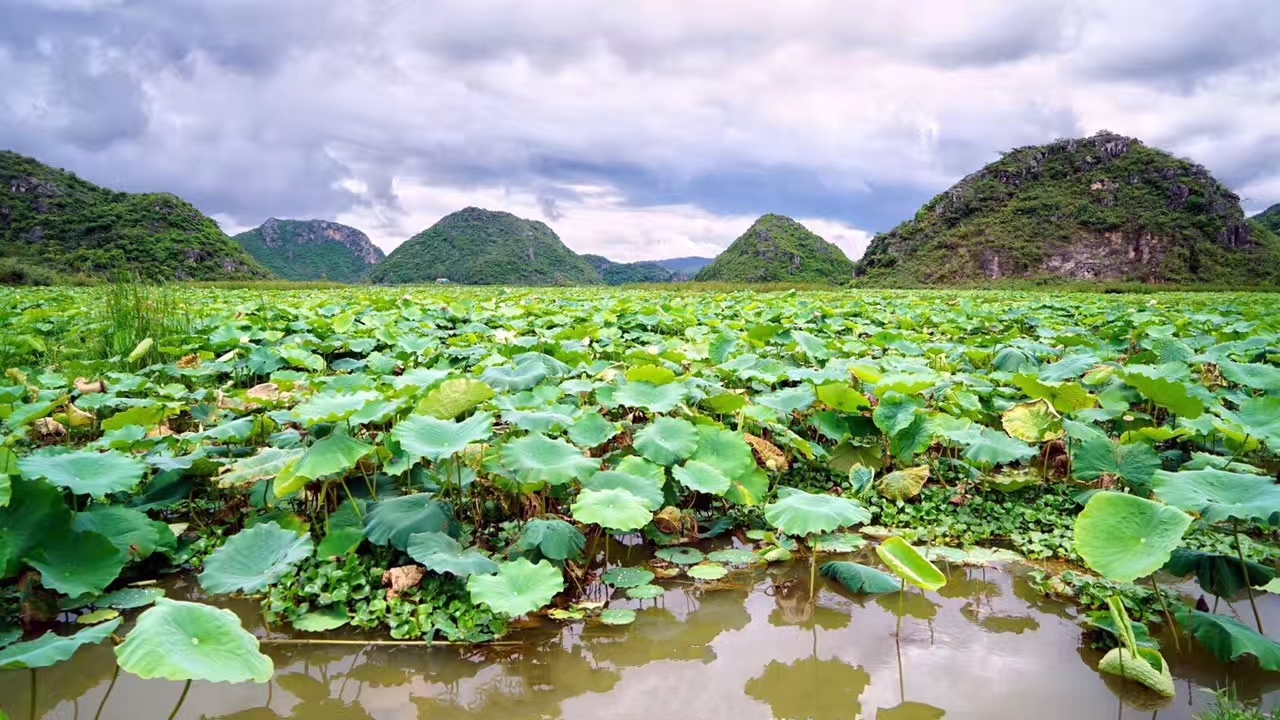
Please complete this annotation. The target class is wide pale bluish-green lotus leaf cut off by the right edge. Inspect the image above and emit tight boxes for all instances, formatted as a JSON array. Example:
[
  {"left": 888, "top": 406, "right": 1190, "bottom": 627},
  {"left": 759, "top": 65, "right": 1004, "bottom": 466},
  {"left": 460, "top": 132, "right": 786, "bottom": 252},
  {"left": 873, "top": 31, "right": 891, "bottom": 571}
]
[{"left": 1151, "top": 469, "right": 1280, "bottom": 523}]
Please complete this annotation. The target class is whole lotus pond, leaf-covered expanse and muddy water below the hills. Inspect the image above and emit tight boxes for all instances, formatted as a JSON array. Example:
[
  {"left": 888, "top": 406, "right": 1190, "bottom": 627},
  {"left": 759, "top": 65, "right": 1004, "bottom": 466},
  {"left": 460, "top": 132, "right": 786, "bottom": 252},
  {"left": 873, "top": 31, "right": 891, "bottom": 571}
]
[{"left": 0, "top": 286, "right": 1280, "bottom": 719}]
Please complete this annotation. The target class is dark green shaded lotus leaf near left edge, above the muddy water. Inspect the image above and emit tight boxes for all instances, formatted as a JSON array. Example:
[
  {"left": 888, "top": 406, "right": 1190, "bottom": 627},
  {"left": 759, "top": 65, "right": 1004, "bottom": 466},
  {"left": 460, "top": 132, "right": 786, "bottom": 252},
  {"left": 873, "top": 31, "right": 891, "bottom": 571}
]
[{"left": 26, "top": 530, "right": 129, "bottom": 597}]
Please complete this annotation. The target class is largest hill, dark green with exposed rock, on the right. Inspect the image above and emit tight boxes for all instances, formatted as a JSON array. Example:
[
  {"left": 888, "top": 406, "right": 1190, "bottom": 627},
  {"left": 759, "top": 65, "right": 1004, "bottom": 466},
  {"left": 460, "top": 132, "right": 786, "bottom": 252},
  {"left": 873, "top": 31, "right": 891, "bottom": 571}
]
[{"left": 858, "top": 131, "right": 1280, "bottom": 284}]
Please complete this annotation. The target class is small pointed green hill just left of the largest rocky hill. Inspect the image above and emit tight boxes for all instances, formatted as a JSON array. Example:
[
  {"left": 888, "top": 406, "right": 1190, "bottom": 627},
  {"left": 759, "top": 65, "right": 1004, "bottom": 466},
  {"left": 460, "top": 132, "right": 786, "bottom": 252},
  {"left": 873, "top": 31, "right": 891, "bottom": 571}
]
[{"left": 695, "top": 214, "right": 854, "bottom": 283}]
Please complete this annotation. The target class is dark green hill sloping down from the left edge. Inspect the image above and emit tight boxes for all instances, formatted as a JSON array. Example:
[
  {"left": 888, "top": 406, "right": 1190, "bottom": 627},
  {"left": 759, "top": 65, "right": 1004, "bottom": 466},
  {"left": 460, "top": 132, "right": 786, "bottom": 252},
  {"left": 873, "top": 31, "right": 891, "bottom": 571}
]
[{"left": 0, "top": 151, "right": 270, "bottom": 281}]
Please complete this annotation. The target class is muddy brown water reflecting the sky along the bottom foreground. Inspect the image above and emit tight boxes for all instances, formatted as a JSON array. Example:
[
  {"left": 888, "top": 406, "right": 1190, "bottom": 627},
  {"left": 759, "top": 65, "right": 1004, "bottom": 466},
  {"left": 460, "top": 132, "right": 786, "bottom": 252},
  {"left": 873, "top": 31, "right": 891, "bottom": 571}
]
[{"left": 0, "top": 566, "right": 1280, "bottom": 720}]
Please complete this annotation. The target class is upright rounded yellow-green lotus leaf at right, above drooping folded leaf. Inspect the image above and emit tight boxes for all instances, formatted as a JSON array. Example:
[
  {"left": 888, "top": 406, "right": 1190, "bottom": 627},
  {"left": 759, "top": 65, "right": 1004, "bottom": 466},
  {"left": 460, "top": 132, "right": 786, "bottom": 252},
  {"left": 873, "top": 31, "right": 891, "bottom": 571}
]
[{"left": 1075, "top": 492, "right": 1192, "bottom": 583}]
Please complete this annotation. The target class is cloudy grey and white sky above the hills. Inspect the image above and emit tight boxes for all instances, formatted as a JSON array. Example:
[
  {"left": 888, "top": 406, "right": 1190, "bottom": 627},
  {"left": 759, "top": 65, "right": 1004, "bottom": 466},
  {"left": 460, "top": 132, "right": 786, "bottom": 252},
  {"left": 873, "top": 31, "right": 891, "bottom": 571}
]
[{"left": 0, "top": 0, "right": 1280, "bottom": 261}]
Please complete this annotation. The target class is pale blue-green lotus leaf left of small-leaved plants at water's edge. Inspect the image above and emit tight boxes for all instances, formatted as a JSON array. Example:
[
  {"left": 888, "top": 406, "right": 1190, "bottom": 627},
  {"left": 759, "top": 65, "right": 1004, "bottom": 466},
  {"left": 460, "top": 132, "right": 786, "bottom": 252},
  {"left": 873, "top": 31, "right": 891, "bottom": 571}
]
[{"left": 200, "top": 521, "right": 315, "bottom": 593}]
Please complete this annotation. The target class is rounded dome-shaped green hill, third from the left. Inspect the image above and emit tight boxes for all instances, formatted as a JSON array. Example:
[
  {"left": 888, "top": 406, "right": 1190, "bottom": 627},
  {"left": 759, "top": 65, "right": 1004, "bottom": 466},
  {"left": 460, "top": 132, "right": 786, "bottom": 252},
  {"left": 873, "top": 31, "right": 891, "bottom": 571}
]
[{"left": 369, "top": 208, "right": 602, "bottom": 286}]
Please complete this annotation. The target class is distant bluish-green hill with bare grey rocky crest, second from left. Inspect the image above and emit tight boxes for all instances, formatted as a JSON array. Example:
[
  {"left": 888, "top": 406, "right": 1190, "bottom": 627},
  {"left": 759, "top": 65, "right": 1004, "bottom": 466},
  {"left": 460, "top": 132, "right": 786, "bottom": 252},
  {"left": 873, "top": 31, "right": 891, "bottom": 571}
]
[{"left": 232, "top": 218, "right": 387, "bottom": 283}]
